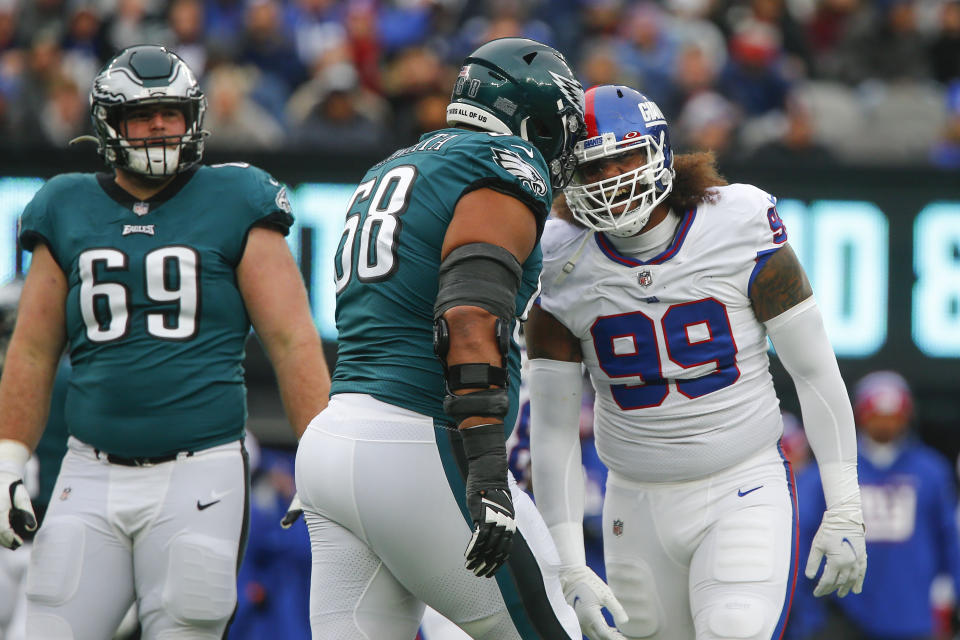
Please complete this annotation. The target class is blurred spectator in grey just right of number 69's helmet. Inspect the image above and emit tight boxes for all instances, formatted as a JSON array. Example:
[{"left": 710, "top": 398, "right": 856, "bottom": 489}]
[{"left": 204, "top": 66, "right": 286, "bottom": 149}]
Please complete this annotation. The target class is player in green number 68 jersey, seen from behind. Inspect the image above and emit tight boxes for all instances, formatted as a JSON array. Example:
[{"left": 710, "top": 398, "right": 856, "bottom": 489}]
[{"left": 296, "top": 38, "right": 584, "bottom": 640}]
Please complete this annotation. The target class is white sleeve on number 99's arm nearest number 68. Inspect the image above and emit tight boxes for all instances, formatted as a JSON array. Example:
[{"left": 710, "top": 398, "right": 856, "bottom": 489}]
[{"left": 530, "top": 358, "right": 586, "bottom": 568}]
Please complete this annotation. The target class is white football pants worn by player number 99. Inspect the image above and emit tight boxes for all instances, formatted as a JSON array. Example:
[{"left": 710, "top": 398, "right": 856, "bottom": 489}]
[{"left": 603, "top": 447, "right": 797, "bottom": 640}]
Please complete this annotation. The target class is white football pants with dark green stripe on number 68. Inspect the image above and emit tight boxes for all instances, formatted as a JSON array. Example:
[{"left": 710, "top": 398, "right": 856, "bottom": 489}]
[{"left": 296, "top": 393, "right": 581, "bottom": 640}]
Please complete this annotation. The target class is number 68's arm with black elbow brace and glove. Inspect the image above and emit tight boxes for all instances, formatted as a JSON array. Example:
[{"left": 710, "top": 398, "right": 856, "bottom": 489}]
[{"left": 434, "top": 189, "right": 537, "bottom": 578}]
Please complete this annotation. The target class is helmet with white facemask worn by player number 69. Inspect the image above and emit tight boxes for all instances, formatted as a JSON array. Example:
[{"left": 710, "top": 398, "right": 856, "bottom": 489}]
[{"left": 90, "top": 45, "right": 207, "bottom": 178}]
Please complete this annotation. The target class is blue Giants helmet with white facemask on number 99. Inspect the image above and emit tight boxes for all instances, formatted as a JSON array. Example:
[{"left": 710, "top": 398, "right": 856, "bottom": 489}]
[{"left": 564, "top": 85, "right": 674, "bottom": 237}]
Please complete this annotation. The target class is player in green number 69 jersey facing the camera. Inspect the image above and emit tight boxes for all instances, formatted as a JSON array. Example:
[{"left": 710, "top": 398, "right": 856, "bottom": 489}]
[{"left": 0, "top": 45, "right": 329, "bottom": 640}]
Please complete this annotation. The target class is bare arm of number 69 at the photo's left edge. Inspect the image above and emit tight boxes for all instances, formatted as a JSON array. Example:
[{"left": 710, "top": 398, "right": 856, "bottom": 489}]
[{"left": 0, "top": 244, "right": 67, "bottom": 451}]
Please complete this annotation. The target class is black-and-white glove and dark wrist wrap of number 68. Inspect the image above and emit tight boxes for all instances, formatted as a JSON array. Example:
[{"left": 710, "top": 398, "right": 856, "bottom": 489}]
[{"left": 460, "top": 424, "right": 517, "bottom": 578}]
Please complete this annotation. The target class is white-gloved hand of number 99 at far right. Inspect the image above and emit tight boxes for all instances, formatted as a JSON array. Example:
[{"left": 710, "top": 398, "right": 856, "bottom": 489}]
[{"left": 804, "top": 504, "right": 867, "bottom": 598}]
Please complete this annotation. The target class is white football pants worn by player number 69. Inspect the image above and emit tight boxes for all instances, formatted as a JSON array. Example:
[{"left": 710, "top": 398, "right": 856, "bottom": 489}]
[{"left": 27, "top": 437, "right": 248, "bottom": 640}]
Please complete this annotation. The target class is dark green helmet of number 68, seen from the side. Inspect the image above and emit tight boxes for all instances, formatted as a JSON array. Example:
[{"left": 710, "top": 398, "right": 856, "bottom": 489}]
[{"left": 447, "top": 38, "right": 586, "bottom": 189}]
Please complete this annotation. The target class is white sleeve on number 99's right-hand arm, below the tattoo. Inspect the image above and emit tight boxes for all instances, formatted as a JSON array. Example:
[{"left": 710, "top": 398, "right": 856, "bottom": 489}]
[{"left": 764, "top": 296, "right": 860, "bottom": 509}]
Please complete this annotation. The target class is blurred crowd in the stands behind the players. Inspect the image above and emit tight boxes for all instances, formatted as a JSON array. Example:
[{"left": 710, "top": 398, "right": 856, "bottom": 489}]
[{"left": 0, "top": 0, "right": 960, "bottom": 168}]
